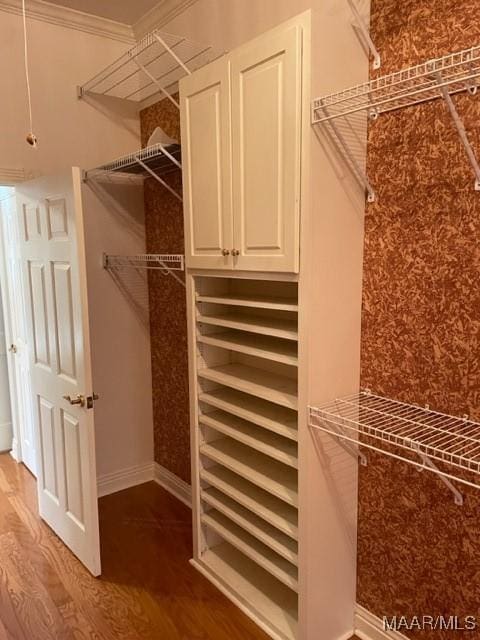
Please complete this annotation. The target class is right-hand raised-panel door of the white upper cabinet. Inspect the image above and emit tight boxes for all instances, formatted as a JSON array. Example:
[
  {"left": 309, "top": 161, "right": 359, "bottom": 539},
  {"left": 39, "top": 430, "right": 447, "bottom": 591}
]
[{"left": 231, "top": 25, "right": 302, "bottom": 272}]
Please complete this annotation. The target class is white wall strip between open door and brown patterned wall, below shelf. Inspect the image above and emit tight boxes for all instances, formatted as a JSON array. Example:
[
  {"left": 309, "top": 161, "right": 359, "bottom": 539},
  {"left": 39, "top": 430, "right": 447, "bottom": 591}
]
[{"left": 82, "top": 182, "right": 153, "bottom": 484}]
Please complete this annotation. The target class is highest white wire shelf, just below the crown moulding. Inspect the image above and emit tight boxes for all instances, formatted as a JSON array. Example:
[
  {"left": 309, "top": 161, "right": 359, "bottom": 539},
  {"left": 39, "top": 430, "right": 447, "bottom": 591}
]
[{"left": 78, "top": 30, "right": 221, "bottom": 106}]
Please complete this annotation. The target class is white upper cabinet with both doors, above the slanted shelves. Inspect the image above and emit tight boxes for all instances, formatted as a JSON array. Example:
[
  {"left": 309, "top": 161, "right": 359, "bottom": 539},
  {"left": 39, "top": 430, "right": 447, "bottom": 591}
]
[{"left": 180, "top": 23, "right": 302, "bottom": 273}]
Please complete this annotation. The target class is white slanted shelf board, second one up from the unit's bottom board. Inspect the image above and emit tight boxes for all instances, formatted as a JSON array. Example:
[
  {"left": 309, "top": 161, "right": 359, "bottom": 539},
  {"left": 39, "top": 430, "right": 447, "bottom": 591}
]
[{"left": 201, "top": 487, "right": 298, "bottom": 567}]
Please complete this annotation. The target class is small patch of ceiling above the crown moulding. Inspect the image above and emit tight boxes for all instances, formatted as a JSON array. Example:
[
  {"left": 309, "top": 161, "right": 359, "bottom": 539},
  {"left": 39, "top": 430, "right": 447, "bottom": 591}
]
[{"left": 48, "top": 0, "right": 163, "bottom": 25}]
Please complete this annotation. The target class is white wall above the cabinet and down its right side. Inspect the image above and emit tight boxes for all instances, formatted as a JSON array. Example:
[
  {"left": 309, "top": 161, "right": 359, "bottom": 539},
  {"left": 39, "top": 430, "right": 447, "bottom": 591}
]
[{"left": 164, "top": 0, "right": 368, "bottom": 640}]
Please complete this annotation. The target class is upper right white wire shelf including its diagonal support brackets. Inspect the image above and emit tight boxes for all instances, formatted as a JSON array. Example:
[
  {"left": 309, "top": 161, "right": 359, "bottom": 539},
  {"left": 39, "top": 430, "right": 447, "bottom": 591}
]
[{"left": 312, "top": 46, "right": 480, "bottom": 201}]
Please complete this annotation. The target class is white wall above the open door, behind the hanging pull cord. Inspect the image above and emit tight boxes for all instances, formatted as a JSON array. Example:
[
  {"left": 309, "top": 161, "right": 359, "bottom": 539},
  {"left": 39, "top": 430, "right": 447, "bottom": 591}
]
[{"left": 0, "top": 11, "right": 139, "bottom": 177}]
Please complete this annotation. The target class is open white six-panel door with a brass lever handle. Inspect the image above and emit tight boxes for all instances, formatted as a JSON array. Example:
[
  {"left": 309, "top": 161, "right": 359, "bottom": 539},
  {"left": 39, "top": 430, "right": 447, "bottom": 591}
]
[{"left": 17, "top": 169, "right": 100, "bottom": 575}]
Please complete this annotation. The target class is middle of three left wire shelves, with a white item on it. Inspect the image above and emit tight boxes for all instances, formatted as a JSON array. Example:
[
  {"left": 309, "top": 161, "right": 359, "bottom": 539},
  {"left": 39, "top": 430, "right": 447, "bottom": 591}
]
[{"left": 84, "top": 143, "right": 182, "bottom": 201}]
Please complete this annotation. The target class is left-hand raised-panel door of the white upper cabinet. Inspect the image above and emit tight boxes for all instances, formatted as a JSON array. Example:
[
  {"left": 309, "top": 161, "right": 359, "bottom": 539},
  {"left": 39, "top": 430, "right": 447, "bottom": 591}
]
[{"left": 180, "top": 52, "right": 233, "bottom": 269}]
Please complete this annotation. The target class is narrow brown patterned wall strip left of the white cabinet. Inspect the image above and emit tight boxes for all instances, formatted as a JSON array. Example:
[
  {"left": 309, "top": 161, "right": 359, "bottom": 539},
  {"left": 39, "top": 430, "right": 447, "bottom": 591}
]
[{"left": 140, "top": 99, "right": 190, "bottom": 482}]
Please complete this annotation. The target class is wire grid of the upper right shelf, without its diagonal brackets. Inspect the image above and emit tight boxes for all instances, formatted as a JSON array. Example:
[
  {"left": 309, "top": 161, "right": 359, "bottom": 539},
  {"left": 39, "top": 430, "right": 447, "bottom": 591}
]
[{"left": 312, "top": 46, "right": 480, "bottom": 124}]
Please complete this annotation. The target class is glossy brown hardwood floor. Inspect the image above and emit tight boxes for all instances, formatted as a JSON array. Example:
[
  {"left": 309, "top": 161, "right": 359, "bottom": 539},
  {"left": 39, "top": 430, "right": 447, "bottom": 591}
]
[{"left": 0, "top": 454, "right": 267, "bottom": 640}]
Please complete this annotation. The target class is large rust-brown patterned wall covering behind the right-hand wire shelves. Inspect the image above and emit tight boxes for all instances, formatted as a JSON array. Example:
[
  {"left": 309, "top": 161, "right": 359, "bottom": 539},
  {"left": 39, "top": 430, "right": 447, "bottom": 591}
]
[{"left": 357, "top": 0, "right": 480, "bottom": 640}]
